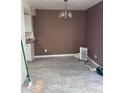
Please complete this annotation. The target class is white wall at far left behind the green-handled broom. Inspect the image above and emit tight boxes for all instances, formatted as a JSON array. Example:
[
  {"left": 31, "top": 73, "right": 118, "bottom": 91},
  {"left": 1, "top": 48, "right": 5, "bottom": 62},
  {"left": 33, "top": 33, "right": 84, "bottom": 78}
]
[{"left": 21, "top": 0, "right": 31, "bottom": 84}]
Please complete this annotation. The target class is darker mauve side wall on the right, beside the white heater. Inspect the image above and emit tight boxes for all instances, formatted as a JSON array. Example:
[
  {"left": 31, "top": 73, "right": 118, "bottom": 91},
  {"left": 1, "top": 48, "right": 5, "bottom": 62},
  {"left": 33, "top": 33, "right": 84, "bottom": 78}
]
[{"left": 86, "top": 2, "right": 103, "bottom": 65}]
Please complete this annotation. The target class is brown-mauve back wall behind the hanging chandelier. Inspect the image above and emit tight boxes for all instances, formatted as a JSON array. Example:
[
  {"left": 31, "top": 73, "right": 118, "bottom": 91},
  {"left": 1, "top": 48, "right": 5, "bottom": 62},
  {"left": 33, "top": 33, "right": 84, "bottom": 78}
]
[{"left": 33, "top": 10, "right": 85, "bottom": 55}]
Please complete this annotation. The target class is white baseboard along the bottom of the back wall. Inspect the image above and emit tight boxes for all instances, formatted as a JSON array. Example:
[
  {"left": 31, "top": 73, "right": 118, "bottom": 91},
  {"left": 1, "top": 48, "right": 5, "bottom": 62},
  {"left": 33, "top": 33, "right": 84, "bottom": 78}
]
[{"left": 34, "top": 54, "right": 75, "bottom": 58}]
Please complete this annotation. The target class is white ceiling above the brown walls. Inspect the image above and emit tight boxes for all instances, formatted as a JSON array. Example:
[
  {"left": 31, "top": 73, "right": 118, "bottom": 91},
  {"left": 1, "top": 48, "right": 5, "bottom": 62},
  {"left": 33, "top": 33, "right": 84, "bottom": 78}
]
[{"left": 30, "top": 0, "right": 102, "bottom": 10}]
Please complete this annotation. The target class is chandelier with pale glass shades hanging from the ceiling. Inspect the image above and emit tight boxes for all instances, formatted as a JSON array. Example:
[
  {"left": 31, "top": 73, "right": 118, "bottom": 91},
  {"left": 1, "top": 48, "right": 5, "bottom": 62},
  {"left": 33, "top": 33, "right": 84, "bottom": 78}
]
[{"left": 58, "top": 0, "right": 72, "bottom": 19}]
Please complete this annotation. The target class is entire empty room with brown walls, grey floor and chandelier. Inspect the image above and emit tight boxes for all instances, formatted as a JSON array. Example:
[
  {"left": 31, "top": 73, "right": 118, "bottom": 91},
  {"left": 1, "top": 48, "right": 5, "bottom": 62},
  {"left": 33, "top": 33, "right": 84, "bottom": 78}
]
[{"left": 21, "top": 0, "right": 103, "bottom": 93}]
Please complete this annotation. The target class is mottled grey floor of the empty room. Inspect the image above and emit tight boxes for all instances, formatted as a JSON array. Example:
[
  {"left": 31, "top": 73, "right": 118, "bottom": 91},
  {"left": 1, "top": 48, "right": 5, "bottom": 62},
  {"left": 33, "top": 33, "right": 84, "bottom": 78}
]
[{"left": 22, "top": 57, "right": 103, "bottom": 93}]
